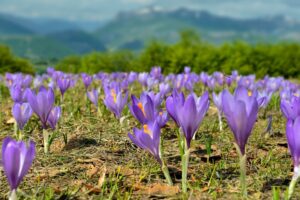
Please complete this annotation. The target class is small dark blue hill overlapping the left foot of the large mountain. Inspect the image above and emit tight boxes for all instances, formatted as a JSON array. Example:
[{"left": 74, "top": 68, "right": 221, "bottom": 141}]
[{"left": 48, "top": 30, "right": 105, "bottom": 54}]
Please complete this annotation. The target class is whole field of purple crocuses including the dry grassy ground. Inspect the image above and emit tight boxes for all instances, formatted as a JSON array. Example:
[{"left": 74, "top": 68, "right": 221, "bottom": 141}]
[{"left": 0, "top": 67, "right": 300, "bottom": 199}]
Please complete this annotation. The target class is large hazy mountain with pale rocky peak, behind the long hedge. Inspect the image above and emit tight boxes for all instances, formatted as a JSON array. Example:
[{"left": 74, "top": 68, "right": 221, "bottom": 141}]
[{"left": 95, "top": 7, "right": 300, "bottom": 49}]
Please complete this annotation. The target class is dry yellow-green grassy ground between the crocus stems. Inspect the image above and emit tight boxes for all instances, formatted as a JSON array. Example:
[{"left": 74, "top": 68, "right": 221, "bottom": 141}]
[{"left": 0, "top": 83, "right": 300, "bottom": 199}]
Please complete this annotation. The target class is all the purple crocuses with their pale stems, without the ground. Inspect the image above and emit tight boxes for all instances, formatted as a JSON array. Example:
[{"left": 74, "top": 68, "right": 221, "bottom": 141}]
[{"left": 0, "top": 67, "right": 300, "bottom": 198}]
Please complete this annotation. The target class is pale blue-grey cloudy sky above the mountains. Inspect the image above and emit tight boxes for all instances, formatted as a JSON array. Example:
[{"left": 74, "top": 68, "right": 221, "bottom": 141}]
[{"left": 0, "top": 0, "right": 300, "bottom": 21}]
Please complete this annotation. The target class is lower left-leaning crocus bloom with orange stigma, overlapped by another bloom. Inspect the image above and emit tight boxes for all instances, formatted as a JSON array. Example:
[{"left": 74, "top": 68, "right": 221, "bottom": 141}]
[{"left": 128, "top": 122, "right": 162, "bottom": 164}]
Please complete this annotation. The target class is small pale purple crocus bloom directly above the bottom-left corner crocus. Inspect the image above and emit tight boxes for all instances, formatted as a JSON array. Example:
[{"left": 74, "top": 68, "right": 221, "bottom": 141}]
[{"left": 12, "top": 103, "right": 32, "bottom": 130}]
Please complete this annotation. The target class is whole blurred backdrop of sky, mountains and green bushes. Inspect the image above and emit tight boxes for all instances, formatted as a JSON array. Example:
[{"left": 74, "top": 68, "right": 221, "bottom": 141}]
[{"left": 0, "top": 0, "right": 300, "bottom": 76}]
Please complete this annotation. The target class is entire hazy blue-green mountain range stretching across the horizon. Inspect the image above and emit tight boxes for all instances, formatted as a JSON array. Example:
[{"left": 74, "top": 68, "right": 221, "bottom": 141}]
[{"left": 0, "top": 7, "right": 300, "bottom": 59}]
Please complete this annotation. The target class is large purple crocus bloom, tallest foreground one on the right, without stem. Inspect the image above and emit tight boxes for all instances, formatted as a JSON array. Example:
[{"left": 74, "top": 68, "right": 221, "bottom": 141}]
[{"left": 222, "top": 87, "right": 258, "bottom": 155}]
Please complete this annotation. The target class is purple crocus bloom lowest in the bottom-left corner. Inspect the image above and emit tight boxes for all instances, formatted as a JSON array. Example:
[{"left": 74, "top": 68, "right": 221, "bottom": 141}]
[{"left": 2, "top": 137, "right": 35, "bottom": 191}]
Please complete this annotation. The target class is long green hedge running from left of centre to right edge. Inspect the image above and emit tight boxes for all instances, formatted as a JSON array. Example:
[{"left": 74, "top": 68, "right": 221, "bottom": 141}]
[{"left": 56, "top": 31, "right": 300, "bottom": 77}]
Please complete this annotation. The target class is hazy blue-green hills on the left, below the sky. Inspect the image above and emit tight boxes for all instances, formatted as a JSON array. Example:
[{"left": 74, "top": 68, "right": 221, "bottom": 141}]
[{"left": 0, "top": 14, "right": 105, "bottom": 59}]
